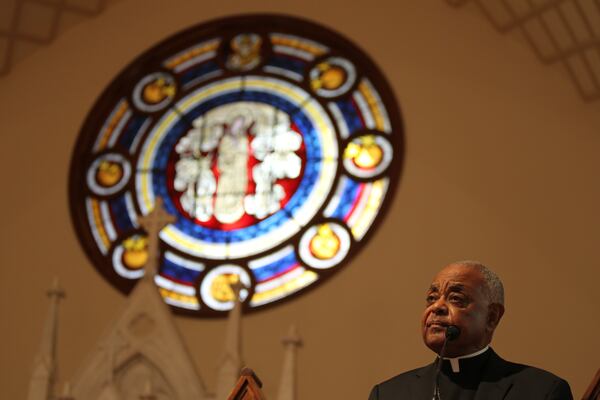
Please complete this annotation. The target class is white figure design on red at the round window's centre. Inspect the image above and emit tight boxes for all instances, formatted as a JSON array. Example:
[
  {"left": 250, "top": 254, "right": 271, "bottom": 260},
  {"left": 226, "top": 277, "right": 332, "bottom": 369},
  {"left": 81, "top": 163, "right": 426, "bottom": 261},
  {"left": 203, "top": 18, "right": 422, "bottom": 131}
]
[{"left": 174, "top": 102, "right": 302, "bottom": 223}]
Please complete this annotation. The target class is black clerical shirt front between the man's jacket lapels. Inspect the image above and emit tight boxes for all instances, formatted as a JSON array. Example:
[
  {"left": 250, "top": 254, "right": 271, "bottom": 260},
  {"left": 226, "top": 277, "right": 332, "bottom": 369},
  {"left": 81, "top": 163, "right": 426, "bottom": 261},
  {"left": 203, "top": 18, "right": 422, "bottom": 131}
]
[{"left": 438, "top": 348, "right": 491, "bottom": 400}]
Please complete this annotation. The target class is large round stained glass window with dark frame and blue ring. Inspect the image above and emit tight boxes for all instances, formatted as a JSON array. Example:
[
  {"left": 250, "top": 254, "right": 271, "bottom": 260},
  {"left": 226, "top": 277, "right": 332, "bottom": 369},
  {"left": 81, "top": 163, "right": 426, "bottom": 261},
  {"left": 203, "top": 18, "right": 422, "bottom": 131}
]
[{"left": 70, "top": 15, "right": 403, "bottom": 316}]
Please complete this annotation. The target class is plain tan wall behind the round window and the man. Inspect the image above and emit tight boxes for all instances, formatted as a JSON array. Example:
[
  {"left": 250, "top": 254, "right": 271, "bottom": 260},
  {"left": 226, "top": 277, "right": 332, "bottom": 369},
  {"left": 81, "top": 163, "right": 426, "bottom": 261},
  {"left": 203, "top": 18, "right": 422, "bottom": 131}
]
[{"left": 0, "top": 0, "right": 600, "bottom": 400}]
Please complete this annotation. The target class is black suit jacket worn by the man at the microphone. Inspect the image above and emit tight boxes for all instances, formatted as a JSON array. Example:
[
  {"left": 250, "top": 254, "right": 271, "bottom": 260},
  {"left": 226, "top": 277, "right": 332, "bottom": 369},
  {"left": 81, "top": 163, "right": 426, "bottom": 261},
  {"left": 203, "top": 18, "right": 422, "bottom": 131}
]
[{"left": 369, "top": 349, "right": 573, "bottom": 400}]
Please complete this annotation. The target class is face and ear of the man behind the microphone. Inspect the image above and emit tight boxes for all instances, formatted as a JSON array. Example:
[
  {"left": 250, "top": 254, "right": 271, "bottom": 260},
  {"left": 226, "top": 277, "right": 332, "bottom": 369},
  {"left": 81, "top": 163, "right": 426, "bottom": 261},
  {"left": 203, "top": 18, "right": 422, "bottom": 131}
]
[{"left": 421, "top": 264, "right": 504, "bottom": 357}]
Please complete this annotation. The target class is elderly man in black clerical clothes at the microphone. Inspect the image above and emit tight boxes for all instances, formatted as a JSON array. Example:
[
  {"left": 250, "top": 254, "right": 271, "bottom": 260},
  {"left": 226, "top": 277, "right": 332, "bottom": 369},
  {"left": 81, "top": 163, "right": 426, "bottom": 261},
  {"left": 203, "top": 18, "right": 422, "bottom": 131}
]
[{"left": 369, "top": 261, "right": 573, "bottom": 400}]
